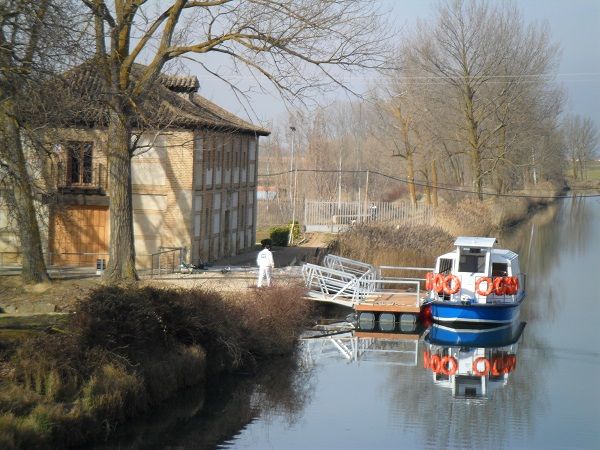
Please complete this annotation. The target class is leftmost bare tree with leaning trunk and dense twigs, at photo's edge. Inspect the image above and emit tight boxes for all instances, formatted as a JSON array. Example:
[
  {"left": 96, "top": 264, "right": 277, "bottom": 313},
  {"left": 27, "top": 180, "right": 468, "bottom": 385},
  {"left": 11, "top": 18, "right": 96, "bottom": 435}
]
[{"left": 0, "top": 0, "right": 85, "bottom": 282}]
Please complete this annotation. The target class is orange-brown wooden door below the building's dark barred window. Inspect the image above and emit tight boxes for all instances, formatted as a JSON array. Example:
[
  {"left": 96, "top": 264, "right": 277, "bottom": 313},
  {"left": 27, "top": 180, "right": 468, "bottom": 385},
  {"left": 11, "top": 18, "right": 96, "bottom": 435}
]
[{"left": 52, "top": 206, "right": 109, "bottom": 266}]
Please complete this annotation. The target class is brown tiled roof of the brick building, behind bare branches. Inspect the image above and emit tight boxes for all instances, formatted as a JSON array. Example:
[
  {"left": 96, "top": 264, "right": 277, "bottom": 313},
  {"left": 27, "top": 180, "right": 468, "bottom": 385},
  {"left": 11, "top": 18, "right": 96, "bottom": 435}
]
[{"left": 54, "top": 62, "right": 270, "bottom": 136}]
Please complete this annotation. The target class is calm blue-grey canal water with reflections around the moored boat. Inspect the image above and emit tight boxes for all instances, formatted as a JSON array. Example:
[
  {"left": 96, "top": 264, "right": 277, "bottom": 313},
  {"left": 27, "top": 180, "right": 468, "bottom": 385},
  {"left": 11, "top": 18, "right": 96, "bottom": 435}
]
[{"left": 109, "top": 198, "right": 600, "bottom": 450}]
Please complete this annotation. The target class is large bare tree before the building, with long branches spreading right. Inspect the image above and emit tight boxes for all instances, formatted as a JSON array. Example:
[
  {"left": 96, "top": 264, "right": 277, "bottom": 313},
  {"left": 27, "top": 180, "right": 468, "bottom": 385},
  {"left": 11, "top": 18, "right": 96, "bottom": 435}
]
[{"left": 81, "top": 0, "right": 386, "bottom": 282}]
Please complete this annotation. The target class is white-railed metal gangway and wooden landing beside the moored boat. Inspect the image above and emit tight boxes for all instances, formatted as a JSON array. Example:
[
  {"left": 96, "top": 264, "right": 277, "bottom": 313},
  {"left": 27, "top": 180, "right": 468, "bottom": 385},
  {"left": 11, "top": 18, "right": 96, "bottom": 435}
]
[{"left": 302, "top": 255, "right": 433, "bottom": 308}]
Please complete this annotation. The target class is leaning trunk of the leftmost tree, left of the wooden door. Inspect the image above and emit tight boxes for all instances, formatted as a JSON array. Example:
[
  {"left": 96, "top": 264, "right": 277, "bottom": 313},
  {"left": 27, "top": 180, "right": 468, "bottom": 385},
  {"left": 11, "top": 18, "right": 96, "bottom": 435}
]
[{"left": 0, "top": 99, "right": 50, "bottom": 283}]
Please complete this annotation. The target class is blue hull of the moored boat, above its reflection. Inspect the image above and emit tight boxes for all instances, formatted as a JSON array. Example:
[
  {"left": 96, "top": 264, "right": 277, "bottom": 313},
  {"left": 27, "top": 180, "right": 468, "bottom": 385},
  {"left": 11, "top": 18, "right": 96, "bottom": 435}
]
[{"left": 430, "top": 300, "right": 521, "bottom": 325}]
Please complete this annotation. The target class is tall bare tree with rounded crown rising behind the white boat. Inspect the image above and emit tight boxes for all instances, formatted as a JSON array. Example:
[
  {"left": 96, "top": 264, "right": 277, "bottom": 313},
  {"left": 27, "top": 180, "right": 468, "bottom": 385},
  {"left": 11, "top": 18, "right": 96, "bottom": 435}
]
[{"left": 400, "top": 0, "right": 560, "bottom": 199}]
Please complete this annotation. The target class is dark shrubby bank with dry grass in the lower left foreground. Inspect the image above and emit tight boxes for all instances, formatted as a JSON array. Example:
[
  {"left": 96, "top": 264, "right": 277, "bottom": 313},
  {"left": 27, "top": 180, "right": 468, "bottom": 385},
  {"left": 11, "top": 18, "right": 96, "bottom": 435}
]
[{"left": 0, "top": 287, "right": 309, "bottom": 448}]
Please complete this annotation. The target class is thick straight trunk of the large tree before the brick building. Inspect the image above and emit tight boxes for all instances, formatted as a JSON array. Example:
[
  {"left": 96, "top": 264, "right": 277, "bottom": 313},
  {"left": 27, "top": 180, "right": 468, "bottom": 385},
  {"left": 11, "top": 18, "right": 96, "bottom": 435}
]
[{"left": 104, "top": 112, "right": 138, "bottom": 284}]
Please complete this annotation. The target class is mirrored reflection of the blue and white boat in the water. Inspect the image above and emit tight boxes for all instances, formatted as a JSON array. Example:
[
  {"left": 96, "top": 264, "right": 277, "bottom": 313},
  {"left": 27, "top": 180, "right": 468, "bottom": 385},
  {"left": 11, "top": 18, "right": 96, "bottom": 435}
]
[{"left": 423, "top": 322, "right": 525, "bottom": 399}]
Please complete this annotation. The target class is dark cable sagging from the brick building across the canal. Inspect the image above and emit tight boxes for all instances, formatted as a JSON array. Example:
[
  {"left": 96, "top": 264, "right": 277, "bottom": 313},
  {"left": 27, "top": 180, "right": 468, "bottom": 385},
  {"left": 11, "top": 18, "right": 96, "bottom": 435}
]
[{"left": 258, "top": 169, "right": 600, "bottom": 200}]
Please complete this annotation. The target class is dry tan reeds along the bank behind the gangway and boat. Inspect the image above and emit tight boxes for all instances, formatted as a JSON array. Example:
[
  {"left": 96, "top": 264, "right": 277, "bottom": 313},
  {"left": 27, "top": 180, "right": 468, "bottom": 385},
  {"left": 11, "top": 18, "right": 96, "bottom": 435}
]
[{"left": 330, "top": 184, "right": 560, "bottom": 268}]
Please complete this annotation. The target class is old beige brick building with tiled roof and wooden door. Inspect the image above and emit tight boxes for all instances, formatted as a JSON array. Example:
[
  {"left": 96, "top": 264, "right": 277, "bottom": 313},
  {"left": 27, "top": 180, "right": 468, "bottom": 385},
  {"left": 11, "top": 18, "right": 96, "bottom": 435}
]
[{"left": 0, "top": 65, "right": 269, "bottom": 267}]
